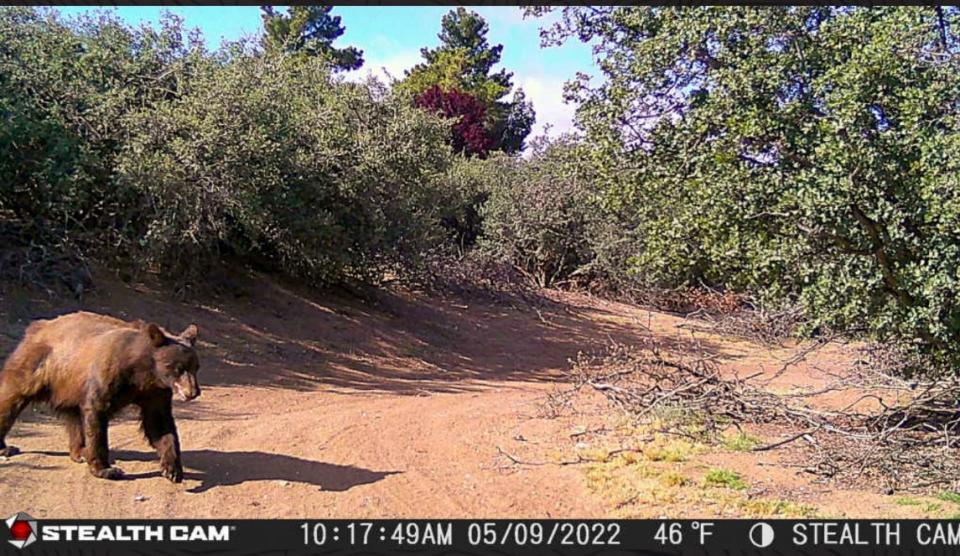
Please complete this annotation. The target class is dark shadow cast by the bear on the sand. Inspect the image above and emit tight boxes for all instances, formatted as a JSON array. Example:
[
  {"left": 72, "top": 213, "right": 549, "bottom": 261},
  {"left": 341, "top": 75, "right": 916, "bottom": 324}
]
[{"left": 110, "top": 450, "right": 400, "bottom": 493}]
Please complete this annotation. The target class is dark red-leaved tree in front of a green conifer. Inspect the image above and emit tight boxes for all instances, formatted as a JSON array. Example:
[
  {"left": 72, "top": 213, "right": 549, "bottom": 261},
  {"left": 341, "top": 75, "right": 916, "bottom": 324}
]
[{"left": 415, "top": 85, "right": 494, "bottom": 157}]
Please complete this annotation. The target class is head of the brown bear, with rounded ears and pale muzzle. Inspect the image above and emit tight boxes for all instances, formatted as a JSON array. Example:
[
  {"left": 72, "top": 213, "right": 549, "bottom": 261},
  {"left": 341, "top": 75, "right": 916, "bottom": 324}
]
[{"left": 141, "top": 323, "right": 200, "bottom": 401}]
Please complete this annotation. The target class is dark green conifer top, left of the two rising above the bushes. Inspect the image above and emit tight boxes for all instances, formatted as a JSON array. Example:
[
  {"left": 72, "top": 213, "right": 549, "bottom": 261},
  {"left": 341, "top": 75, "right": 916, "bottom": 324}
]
[{"left": 260, "top": 6, "right": 363, "bottom": 71}]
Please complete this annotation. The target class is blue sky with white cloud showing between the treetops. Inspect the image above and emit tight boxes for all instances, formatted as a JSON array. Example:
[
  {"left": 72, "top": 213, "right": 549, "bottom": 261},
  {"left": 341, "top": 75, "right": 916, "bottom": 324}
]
[{"left": 58, "top": 6, "right": 598, "bottom": 137}]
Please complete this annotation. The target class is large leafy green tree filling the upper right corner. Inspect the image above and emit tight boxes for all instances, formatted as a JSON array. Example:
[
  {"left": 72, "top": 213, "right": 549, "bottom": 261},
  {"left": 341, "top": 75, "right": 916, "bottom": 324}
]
[{"left": 532, "top": 6, "right": 960, "bottom": 365}]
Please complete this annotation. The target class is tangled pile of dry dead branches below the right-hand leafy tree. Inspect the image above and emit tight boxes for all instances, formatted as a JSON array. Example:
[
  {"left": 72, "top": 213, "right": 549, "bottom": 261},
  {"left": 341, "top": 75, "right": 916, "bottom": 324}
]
[{"left": 569, "top": 340, "right": 960, "bottom": 490}]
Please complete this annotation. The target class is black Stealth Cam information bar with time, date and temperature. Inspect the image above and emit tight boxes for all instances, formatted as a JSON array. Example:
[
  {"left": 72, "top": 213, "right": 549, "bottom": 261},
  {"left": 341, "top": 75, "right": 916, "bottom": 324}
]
[{"left": 0, "top": 514, "right": 960, "bottom": 556}]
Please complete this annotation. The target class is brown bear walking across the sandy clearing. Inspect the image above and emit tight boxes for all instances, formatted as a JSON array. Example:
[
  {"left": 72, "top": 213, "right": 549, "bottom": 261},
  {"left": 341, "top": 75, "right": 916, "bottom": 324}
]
[{"left": 0, "top": 311, "right": 200, "bottom": 483}]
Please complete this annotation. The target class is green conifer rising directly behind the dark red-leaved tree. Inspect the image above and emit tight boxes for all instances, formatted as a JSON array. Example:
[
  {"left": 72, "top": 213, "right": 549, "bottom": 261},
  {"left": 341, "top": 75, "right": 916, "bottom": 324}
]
[{"left": 398, "top": 7, "right": 536, "bottom": 153}]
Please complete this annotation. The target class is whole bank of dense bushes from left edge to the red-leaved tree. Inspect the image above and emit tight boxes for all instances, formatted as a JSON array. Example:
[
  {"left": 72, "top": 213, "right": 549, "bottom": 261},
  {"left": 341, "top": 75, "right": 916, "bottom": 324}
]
[{"left": 0, "top": 9, "right": 453, "bottom": 283}]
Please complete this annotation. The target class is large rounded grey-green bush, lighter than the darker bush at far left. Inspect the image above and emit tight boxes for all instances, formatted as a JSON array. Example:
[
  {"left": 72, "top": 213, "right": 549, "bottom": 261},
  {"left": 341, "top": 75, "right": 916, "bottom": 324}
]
[{"left": 117, "top": 54, "right": 450, "bottom": 283}]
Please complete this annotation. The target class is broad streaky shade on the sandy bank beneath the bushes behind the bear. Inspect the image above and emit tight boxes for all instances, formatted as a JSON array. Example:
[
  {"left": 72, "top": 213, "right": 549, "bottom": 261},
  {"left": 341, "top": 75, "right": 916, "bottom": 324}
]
[{"left": 0, "top": 275, "right": 713, "bottom": 396}]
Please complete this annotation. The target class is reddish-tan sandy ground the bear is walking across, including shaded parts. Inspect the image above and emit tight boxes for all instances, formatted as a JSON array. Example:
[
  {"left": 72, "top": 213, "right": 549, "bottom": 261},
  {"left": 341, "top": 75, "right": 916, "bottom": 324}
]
[{"left": 0, "top": 277, "right": 948, "bottom": 518}]
